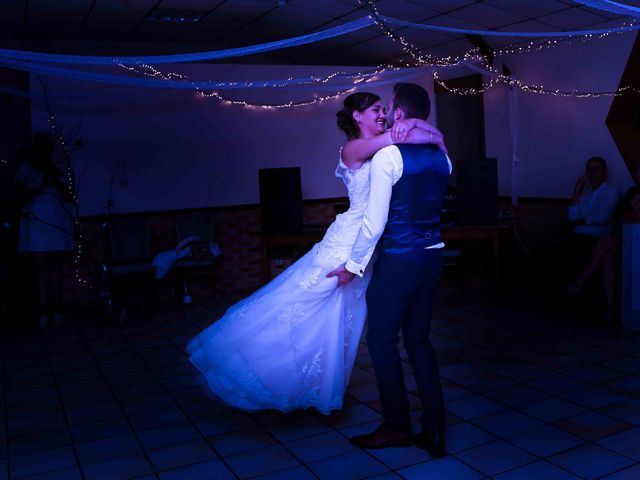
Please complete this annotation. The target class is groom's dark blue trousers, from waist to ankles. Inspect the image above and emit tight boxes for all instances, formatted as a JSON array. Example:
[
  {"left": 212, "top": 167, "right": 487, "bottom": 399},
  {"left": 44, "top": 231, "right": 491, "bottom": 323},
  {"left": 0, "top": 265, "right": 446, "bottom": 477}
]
[{"left": 367, "top": 249, "right": 445, "bottom": 433}]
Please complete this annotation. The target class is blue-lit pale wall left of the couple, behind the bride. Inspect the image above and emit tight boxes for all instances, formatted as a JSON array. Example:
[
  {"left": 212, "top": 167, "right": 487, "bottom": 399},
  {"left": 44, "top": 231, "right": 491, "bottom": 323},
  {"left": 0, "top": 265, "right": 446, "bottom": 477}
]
[{"left": 31, "top": 65, "right": 433, "bottom": 214}]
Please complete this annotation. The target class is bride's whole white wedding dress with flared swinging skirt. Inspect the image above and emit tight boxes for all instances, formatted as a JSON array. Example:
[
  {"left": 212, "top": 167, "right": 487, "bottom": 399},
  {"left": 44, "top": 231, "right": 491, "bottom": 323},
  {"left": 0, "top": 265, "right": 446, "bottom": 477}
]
[{"left": 187, "top": 162, "right": 371, "bottom": 415}]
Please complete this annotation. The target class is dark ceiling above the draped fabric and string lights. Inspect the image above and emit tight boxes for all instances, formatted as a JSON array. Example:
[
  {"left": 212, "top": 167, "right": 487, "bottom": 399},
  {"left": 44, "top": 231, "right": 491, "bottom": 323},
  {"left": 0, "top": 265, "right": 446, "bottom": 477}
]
[{"left": 0, "top": 0, "right": 640, "bottom": 65}]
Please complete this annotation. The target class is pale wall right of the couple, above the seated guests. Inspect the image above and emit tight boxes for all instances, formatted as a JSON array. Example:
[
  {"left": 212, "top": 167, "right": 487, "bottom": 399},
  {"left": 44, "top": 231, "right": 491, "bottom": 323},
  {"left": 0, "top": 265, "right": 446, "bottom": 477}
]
[{"left": 484, "top": 33, "right": 635, "bottom": 198}]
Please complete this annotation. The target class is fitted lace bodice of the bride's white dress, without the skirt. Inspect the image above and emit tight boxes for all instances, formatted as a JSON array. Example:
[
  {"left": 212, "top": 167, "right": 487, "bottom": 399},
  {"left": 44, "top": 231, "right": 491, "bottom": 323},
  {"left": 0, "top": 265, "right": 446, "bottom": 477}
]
[{"left": 317, "top": 160, "right": 371, "bottom": 265}]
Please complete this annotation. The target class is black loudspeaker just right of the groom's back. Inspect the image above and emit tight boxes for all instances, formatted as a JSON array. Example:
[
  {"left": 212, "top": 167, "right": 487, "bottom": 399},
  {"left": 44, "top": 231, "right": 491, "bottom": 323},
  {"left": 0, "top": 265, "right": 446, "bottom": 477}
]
[{"left": 456, "top": 158, "right": 500, "bottom": 225}]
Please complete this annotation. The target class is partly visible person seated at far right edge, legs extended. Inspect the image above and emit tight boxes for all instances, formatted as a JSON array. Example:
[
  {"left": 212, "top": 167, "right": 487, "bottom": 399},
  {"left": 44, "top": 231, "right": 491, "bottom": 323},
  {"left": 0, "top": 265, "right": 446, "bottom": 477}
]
[{"left": 566, "top": 187, "right": 640, "bottom": 321}]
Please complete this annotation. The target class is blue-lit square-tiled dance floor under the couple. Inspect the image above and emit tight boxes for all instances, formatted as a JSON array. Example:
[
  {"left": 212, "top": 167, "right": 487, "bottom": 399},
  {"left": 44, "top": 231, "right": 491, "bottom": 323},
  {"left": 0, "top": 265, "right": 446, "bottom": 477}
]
[{"left": 0, "top": 296, "right": 640, "bottom": 480}]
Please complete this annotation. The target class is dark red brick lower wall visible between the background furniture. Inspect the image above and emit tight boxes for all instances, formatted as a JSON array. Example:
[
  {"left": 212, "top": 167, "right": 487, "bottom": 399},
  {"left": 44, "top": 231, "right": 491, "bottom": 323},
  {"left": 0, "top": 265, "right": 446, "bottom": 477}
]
[{"left": 65, "top": 199, "right": 567, "bottom": 304}]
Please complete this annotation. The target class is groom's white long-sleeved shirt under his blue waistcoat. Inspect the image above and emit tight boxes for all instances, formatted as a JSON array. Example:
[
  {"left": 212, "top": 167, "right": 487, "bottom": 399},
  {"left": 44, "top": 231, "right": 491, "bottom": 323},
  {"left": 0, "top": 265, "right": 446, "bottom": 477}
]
[{"left": 345, "top": 145, "right": 452, "bottom": 276}]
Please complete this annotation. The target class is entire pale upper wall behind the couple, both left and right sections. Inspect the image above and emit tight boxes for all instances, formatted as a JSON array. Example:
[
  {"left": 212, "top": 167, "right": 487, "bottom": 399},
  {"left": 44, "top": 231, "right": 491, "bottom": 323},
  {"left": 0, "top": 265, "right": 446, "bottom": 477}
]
[{"left": 32, "top": 34, "right": 635, "bottom": 214}]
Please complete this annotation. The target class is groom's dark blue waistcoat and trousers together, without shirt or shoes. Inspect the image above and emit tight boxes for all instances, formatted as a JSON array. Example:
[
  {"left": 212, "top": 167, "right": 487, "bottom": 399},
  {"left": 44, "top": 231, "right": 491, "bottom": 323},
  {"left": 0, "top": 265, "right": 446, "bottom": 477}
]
[{"left": 367, "top": 145, "right": 449, "bottom": 433}]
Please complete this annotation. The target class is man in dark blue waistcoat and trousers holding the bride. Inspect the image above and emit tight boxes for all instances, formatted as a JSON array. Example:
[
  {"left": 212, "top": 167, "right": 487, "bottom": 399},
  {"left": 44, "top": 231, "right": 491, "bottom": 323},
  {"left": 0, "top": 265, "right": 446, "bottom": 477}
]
[{"left": 329, "top": 83, "right": 451, "bottom": 457}]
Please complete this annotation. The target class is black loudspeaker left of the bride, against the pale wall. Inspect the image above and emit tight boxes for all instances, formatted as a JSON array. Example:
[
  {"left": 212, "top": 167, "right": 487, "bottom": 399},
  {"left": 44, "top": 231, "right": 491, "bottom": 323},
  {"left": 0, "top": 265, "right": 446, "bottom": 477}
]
[{"left": 258, "top": 167, "right": 302, "bottom": 233}]
